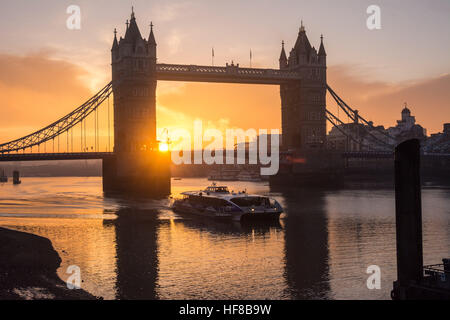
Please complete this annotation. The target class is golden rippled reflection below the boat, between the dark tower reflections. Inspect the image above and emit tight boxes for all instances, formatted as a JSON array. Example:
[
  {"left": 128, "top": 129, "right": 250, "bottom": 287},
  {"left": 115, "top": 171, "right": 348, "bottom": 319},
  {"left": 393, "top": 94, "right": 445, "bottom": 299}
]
[{"left": 158, "top": 220, "right": 288, "bottom": 299}]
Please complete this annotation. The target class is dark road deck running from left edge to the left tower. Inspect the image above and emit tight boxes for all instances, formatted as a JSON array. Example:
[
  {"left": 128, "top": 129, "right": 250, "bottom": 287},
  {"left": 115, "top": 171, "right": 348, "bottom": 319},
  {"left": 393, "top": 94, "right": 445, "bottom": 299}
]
[{"left": 0, "top": 152, "right": 114, "bottom": 162}]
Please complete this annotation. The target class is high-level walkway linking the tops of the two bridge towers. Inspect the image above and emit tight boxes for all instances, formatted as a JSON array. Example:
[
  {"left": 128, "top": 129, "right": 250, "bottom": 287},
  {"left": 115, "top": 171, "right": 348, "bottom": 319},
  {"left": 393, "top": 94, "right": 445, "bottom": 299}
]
[{"left": 156, "top": 64, "right": 300, "bottom": 85}]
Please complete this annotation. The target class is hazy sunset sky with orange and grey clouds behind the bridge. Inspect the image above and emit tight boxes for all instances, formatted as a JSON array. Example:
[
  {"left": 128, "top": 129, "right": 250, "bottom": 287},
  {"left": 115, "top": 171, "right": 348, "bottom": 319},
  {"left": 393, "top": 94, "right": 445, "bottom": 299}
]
[{"left": 0, "top": 0, "right": 450, "bottom": 141}]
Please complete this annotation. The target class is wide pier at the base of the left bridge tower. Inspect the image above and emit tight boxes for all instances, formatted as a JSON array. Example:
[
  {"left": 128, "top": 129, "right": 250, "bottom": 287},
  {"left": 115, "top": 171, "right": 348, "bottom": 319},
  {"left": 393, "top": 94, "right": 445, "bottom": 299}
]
[{"left": 102, "top": 151, "right": 171, "bottom": 197}]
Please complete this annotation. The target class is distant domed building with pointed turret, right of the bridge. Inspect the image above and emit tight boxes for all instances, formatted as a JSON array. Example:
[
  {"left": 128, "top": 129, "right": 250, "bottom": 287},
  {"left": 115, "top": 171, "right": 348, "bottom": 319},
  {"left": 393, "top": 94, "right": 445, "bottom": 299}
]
[{"left": 388, "top": 104, "right": 427, "bottom": 144}]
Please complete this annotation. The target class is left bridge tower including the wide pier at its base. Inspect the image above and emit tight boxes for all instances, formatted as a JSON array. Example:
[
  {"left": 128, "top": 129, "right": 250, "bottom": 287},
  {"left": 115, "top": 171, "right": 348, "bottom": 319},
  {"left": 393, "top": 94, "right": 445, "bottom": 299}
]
[{"left": 103, "top": 11, "right": 170, "bottom": 195}]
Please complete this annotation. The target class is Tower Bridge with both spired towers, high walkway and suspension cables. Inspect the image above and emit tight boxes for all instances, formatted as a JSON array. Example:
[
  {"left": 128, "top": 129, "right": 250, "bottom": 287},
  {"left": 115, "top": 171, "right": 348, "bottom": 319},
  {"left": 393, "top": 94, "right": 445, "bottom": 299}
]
[{"left": 0, "top": 12, "right": 398, "bottom": 194}]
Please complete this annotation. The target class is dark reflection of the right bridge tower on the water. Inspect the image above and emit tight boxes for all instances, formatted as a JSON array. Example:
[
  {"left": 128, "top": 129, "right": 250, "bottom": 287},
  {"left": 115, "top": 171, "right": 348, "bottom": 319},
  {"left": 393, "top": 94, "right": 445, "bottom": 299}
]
[{"left": 281, "top": 190, "right": 330, "bottom": 299}]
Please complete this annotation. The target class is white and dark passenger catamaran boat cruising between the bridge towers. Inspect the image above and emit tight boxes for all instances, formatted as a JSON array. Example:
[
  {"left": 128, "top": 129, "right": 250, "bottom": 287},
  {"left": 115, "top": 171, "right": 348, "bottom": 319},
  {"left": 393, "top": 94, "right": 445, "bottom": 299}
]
[{"left": 172, "top": 183, "right": 283, "bottom": 221}]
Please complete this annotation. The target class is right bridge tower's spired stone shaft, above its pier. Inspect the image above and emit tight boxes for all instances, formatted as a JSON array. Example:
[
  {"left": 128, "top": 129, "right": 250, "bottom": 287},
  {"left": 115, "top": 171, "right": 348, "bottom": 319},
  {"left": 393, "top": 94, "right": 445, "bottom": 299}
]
[{"left": 279, "top": 22, "right": 327, "bottom": 153}]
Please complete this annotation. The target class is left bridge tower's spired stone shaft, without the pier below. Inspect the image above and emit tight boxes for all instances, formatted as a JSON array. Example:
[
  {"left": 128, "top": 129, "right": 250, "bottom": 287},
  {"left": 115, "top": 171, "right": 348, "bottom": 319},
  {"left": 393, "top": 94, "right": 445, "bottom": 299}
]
[{"left": 111, "top": 8, "right": 157, "bottom": 153}]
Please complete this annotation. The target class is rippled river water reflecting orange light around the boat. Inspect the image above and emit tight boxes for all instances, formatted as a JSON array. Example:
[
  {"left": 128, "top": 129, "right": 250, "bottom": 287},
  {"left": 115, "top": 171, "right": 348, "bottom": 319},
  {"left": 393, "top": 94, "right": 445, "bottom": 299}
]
[{"left": 0, "top": 177, "right": 450, "bottom": 299}]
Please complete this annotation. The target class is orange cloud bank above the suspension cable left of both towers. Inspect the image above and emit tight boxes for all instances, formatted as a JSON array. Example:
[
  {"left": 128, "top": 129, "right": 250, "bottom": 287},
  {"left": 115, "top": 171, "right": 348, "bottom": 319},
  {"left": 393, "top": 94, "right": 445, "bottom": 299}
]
[{"left": 0, "top": 52, "right": 91, "bottom": 142}]
